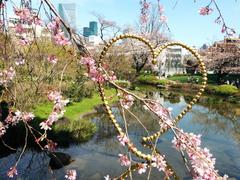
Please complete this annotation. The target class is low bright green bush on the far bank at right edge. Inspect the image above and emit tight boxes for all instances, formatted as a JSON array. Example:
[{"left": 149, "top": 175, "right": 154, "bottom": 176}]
[{"left": 212, "top": 84, "right": 238, "bottom": 95}]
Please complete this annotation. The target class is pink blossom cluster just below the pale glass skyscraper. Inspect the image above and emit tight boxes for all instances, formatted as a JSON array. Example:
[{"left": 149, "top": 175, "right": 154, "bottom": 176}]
[{"left": 47, "top": 18, "right": 69, "bottom": 46}]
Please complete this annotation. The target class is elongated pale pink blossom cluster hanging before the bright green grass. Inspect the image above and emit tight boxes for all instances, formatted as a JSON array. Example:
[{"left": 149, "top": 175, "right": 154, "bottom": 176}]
[{"left": 40, "top": 91, "right": 69, "bottom": 131}]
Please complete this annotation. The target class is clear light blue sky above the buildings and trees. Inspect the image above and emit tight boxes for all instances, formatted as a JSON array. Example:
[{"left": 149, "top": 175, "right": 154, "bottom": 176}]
[{"left": 22, "top": 0, "right": 240, "bottom": 47}]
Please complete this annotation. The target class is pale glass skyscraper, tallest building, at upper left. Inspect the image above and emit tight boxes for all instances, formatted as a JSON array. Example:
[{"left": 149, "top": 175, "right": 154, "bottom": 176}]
[{"left": 58, "top": 3, "right": 77, "bottom": 29}]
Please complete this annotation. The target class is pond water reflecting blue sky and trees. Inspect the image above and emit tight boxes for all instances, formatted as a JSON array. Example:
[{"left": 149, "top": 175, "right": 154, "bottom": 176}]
[{"left": 0, "top": 91, "right": 240, "bottom": 180}]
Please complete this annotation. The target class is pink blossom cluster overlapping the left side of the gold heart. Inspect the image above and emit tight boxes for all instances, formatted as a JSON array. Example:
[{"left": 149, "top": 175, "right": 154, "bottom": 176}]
[{"left": 80, "top": 57, "right": 116, "bottom": 83}]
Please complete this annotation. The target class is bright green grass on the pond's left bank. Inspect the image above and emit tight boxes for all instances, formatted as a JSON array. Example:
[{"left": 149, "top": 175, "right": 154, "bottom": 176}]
[{"left": 34, "top": 89, "right": 117, "bottom": 120}]
